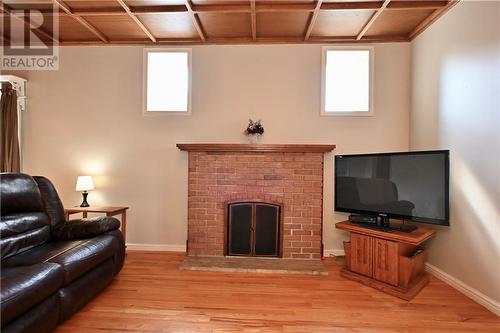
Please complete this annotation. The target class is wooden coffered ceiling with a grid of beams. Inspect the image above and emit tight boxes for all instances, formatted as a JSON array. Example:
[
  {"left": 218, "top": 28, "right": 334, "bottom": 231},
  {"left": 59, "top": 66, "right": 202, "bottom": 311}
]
[{"left": 0, "top": 0, "right": 457, "bottom": 45}]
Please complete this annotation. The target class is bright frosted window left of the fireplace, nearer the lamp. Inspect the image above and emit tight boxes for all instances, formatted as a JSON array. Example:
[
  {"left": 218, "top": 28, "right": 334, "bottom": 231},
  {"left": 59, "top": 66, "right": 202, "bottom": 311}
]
[{"left": 146, "top": 51, "right": 190, "bottom": 112}]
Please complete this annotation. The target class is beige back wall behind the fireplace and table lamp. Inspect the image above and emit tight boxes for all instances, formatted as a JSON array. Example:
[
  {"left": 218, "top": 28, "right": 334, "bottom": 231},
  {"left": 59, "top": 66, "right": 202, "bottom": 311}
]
[{"left": 12, "top": 44, "right": 410, "bottom": 249}]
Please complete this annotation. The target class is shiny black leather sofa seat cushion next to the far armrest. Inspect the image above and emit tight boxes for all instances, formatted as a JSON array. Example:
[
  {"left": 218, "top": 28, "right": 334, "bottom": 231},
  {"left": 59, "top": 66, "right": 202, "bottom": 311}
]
[{"left": 2, "top": 235, "right": 119, "bottom": 285}]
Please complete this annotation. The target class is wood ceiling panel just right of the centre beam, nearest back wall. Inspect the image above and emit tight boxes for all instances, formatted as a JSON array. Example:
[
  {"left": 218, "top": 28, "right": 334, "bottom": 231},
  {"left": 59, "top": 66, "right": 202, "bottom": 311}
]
[{"left": 257, "top": 12, "right": 311, "bottom": 37}]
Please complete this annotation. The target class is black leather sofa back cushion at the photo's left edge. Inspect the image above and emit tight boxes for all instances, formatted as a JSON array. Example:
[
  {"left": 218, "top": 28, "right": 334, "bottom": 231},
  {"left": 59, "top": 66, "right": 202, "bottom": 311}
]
[{"left": 0, "top": 173, "right": 50, "bottom": 259}]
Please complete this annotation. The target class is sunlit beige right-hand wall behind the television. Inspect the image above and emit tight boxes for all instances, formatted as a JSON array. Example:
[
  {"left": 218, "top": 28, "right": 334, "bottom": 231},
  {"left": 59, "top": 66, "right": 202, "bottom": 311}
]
[{"left": 411, "top": 2, "right": 500, "bottom": 301}]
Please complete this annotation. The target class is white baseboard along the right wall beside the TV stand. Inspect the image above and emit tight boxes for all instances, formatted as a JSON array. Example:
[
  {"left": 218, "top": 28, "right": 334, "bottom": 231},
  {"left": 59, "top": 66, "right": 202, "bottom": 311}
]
[{"left": 425, "top": 263, "right": 500, "bottom": 316}]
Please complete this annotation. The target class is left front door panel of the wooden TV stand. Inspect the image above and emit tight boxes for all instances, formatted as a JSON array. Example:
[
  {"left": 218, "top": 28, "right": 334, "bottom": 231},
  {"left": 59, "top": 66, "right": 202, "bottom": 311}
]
[{"left": 351, "top": 233, "right": 373, "bottom": 277}]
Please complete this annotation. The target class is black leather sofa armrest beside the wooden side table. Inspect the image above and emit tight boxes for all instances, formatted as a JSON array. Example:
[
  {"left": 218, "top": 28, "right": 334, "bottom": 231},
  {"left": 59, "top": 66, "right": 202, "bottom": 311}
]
[{"left": 52, "top": 216, "right": 120, "bottom": 240}]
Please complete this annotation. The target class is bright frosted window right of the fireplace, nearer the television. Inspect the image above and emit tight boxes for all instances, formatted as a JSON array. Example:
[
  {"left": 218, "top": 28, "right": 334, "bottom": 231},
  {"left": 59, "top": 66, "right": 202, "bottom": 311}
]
[{"left": 323, "top": 50, "right": 371, "bottom": 114}]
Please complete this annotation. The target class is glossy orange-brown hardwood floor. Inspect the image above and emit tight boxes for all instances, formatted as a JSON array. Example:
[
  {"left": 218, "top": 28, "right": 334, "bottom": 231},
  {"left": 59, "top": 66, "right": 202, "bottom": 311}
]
[{"left": 56, "top": 252, "right": 500, "bottom": 333}]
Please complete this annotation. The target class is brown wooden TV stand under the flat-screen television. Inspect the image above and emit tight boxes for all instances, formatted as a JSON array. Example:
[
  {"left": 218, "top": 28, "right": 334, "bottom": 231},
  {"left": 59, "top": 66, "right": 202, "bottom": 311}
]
[{"left": 335, "top": 221, "right": 436, "bottom": 301}]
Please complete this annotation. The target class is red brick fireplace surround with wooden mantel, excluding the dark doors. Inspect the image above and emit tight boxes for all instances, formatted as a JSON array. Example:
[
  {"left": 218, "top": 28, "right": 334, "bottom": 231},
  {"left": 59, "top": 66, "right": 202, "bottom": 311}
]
[{"left": 177, "top": 144, "right": 335, "bottom": 259}]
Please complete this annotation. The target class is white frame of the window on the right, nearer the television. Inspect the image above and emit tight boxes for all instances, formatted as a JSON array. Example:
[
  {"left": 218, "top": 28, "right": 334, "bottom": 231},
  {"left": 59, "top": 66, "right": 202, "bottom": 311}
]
[{"left": 320, "top": 46, "right": 375, "bottom": 117}]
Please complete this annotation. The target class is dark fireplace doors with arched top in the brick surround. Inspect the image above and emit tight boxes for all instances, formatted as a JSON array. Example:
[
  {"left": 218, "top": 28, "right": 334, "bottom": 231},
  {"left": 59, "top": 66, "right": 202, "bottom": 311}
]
[{"left": 226, "top": 202, "right": 281, "bottom": 257}]
